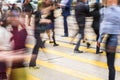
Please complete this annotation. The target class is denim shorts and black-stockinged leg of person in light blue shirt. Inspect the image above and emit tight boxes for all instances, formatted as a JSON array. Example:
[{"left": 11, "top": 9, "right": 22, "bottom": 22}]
[{"left": 106, "top": 35, "right": 118, "bottom": 80}]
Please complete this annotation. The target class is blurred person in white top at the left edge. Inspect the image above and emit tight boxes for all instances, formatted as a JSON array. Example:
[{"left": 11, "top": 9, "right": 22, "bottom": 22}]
[{"left": 0, "top": 19, "right": 12, "bottom": 80}]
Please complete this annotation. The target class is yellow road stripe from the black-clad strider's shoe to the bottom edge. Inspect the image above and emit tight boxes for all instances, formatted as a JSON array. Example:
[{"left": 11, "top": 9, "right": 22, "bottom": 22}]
[{"left": 37, "top": 60, "right": 103, "bottom": 80}]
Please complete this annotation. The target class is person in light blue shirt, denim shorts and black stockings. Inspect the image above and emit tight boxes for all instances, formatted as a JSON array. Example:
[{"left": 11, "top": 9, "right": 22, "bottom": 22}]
[{"left": 97, "top": 0, "right": 120, "bottom": 80}]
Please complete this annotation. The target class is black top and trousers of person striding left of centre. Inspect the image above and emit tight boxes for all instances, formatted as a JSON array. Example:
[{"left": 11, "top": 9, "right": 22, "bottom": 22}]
[{"left": 29, "top": 11, "right": 44, "bottom": 67}]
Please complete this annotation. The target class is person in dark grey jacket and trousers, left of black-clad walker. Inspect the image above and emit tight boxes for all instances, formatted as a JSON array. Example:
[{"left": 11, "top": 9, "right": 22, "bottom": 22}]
[{"left": 74, "top": 0, "right": 89, "bottom": 53}]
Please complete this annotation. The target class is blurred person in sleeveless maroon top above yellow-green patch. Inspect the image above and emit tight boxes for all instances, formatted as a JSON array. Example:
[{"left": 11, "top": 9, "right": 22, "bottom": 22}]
[{"left": 6, "top": 7, "right": 27, "bottom": 80}]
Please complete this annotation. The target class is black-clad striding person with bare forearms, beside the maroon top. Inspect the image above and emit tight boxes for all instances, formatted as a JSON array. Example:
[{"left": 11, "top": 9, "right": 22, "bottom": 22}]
[{"left": 29, "top": 5, "right": 51, "bottom": 69}]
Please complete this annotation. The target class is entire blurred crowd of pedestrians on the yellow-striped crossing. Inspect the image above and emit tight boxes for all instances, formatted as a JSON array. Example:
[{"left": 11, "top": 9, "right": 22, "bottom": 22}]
[{"left": 0, "top": 0, "right": 120, "bottom": 80}]
